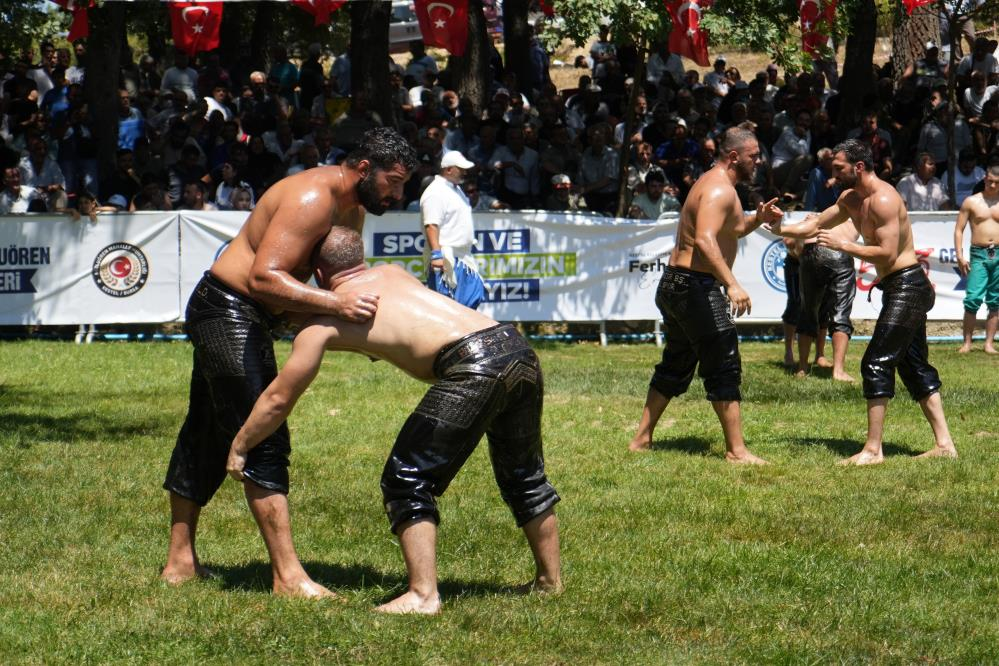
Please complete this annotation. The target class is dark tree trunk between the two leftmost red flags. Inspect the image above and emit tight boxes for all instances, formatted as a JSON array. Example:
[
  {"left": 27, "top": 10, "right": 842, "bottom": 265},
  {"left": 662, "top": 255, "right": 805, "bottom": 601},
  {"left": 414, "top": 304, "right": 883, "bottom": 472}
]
[{"left": 83, "top": 2, "right": 126, "bottom": 188}]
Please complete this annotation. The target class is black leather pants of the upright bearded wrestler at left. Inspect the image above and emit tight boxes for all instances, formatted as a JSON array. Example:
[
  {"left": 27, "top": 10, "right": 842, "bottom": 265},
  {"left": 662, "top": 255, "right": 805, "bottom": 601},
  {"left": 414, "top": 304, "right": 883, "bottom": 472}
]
[{"left": 163, "top": 273, "right": 291, "bottom": 506}]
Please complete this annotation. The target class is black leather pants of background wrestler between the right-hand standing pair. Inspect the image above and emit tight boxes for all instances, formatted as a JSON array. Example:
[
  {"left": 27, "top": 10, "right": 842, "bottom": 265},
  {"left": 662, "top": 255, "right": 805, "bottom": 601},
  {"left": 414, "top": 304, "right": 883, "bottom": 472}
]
[{"left": 798, "top": 243, "right": 857, "bottom": 338}]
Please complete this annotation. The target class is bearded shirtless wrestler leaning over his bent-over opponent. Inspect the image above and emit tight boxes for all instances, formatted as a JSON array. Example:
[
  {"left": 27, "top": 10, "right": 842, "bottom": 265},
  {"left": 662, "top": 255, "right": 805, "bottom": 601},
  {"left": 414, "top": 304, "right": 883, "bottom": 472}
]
[{"left": 162, "top": 129, "right": 416, "bottom": 597}]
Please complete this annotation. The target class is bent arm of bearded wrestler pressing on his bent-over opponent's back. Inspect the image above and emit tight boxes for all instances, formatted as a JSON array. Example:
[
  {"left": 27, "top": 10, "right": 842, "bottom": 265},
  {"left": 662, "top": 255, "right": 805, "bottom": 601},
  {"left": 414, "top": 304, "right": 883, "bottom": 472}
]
[{"left": 249, "top": 195, "right": 378, "bottom": 322}]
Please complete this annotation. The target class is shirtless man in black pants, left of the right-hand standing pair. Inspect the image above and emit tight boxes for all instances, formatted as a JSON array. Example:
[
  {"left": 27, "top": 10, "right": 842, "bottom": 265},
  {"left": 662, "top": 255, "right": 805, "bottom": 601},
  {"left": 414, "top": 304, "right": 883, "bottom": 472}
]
[{"left": 628, "top": 128, "right": 784, "bottom": 464}]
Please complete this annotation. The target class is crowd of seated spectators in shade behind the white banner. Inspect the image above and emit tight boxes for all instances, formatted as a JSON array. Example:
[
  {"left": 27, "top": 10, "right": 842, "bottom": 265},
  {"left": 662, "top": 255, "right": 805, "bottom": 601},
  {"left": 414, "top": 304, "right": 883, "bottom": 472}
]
[{"left": 0, "top": 27, "right": 999, "bottom": 219}]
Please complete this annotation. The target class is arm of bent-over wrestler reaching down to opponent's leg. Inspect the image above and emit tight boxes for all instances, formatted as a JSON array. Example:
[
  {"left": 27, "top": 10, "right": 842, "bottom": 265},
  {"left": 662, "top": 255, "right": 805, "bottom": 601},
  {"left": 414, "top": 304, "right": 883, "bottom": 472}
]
[{"left": 226, "top": 325, "right": 326, "bottom": 481}]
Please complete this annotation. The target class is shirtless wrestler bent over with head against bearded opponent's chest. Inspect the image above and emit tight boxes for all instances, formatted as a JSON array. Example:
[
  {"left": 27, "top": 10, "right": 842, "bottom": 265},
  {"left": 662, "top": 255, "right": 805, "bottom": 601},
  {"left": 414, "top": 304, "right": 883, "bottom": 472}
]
[{"left": 227, "top": 228, "right": 562, "bottom": 614}]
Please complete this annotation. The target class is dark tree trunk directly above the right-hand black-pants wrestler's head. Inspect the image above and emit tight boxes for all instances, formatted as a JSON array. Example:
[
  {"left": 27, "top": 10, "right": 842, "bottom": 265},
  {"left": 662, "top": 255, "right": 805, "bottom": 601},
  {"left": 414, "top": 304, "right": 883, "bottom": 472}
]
[{"left": 836, "top": 0, "right": 878, "bottom": 135}]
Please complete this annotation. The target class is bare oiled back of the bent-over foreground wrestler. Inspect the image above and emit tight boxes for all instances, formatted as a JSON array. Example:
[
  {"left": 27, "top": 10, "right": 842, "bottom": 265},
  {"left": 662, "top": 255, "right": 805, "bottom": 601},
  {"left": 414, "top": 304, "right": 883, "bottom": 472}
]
[{"left": 296, "top": 265, "right": 496, "bottom": 383}]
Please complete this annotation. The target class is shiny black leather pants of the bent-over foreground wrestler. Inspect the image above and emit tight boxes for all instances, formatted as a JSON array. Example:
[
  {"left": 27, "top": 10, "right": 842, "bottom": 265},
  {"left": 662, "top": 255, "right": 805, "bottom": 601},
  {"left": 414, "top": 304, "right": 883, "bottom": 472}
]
[{"left": 381, "top": 324, "right": 559, "bottom": 532}]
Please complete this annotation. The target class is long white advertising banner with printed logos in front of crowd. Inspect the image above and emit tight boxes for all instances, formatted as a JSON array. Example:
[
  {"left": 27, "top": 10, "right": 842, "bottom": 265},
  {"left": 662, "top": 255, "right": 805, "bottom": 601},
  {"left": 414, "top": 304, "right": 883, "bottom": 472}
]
[{"left": 0, "top": 206, "right": 970, "bottom": 325}]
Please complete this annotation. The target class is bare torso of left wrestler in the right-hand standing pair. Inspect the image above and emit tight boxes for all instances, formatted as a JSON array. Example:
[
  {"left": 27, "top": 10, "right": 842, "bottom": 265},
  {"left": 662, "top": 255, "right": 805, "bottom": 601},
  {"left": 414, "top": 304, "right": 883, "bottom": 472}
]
[{"left": 669, "top": 167, "right": 743, "bottom": 273}]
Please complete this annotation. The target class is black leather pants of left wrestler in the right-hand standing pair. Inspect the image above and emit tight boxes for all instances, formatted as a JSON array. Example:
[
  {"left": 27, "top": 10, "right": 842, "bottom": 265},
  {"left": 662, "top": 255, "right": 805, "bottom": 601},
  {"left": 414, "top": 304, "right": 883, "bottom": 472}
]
[{"left": 650, "top": 267, "right": 742, "bottom": 402}]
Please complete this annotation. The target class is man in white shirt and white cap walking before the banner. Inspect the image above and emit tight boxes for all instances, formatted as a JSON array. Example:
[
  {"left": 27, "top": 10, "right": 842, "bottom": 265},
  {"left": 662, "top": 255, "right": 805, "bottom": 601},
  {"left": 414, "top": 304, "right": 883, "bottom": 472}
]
[{"left": 420, "top": 150, "right": 485, "bottom": 309}]
